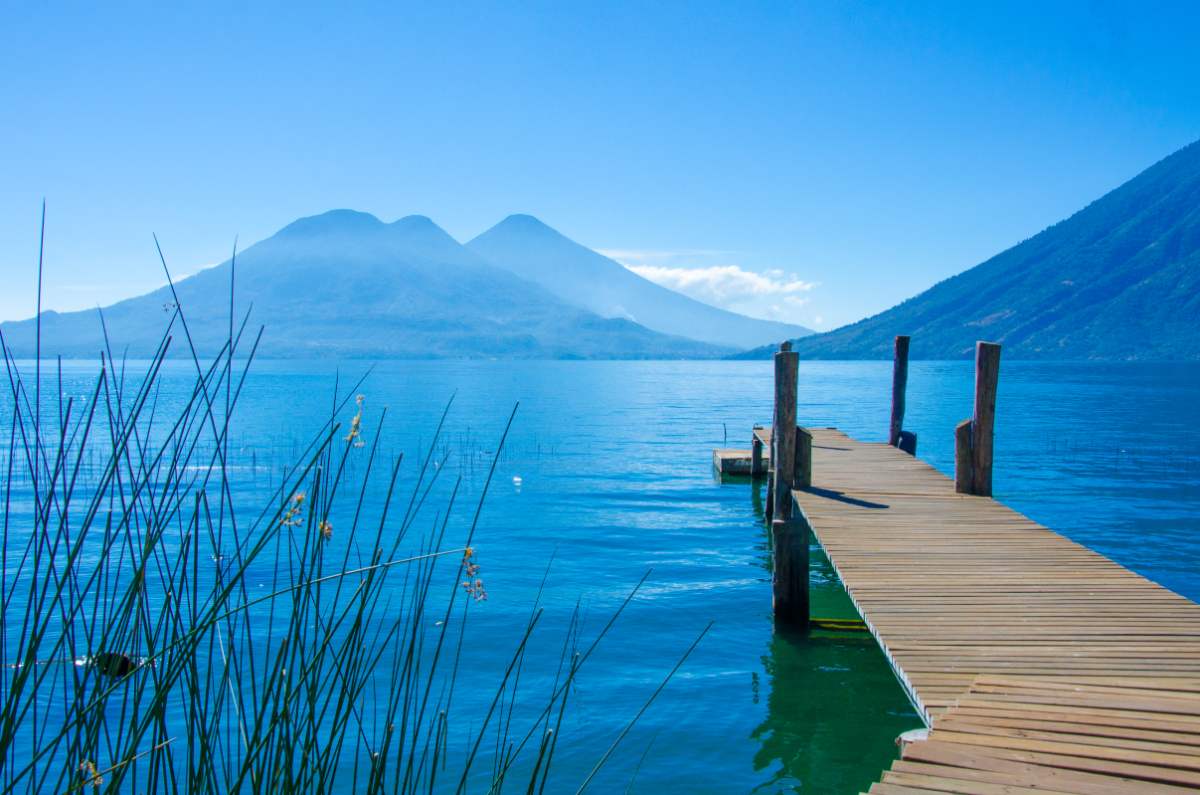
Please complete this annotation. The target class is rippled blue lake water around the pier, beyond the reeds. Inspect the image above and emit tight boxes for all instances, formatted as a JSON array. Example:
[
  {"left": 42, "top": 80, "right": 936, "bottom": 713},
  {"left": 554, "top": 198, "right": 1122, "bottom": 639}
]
[{"left": 4, "top": 361, "right": 1200, "bottom": 793}]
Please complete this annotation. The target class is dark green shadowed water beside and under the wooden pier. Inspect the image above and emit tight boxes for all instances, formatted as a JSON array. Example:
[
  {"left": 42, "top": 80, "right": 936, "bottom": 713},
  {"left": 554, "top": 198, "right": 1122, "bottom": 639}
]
[{"left": 750, "top": 485, "right": 923, "bottom": 793}]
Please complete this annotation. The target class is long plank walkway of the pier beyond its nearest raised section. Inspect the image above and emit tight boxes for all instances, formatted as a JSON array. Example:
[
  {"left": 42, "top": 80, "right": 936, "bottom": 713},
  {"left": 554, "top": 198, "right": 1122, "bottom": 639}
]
[{"left": 793, "top": 437, "right": 1200, "bottom": 722}]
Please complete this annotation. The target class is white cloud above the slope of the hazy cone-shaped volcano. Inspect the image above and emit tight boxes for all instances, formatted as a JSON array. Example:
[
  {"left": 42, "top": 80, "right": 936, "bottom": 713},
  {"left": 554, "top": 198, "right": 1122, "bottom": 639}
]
[{"left": 601, "top": 250, "right": 817, "bottom": 324}]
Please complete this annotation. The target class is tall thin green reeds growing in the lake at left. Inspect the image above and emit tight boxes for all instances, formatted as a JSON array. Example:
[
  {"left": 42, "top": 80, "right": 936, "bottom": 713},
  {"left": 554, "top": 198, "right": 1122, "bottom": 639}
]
[{"left": 0, "top": 234, "right": 698, "bottom": 793}]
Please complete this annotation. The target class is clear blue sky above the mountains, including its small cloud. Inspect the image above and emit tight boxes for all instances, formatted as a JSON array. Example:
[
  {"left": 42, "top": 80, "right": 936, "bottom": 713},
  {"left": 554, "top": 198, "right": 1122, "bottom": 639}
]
[{"left": 0, "top": 1, "right": 1200, "bottom": 329}]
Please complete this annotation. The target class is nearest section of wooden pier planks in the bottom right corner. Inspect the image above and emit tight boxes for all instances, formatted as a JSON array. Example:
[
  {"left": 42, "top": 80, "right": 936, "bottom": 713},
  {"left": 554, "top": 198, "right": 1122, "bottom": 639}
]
[{"left": 870, "top": 675, "right": 1200, "bottom": 795}]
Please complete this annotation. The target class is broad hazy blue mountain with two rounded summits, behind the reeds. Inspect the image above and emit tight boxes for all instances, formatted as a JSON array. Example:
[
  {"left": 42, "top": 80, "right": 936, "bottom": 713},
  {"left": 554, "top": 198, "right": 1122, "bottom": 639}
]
[{"left": 0, "top": 210, "right": 728, "bottom": 358}]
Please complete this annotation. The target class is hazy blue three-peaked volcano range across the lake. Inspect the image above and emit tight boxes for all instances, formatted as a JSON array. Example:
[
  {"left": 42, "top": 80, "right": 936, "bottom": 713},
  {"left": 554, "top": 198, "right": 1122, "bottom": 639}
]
[{"left": 0, "top": 210, "right": 803, "bottom": 358}]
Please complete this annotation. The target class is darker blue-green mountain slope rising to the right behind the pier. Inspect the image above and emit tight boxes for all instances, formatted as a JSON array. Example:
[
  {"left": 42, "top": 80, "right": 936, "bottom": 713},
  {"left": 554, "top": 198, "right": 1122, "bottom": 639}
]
[{"left": 742, "top": 142, "right": 1200, "bottom": 360}]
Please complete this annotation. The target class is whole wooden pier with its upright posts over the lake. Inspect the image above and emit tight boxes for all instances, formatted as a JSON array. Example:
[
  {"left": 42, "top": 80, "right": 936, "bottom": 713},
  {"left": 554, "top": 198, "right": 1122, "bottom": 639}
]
[{"left": 715, "top": 342, "right": 1200, "bottom": 795}]
